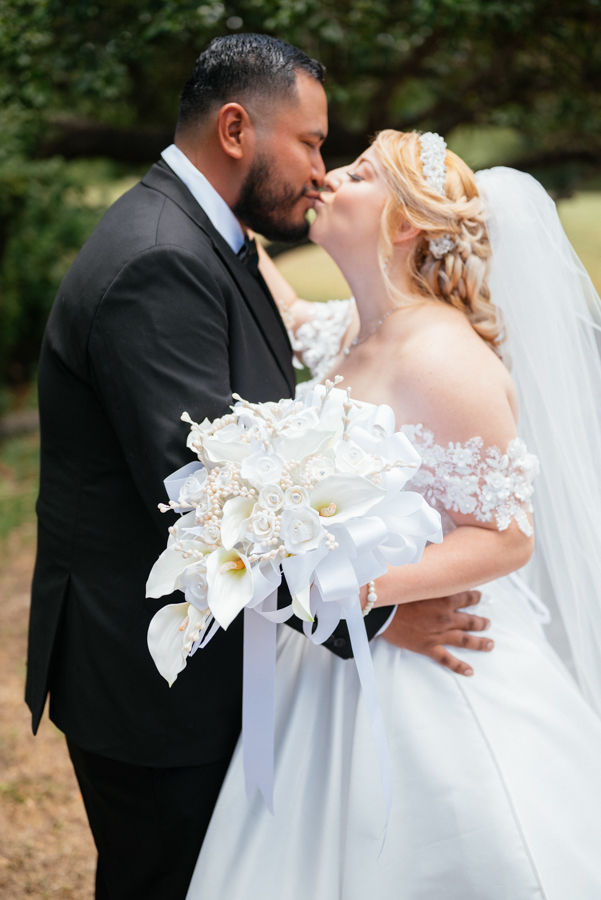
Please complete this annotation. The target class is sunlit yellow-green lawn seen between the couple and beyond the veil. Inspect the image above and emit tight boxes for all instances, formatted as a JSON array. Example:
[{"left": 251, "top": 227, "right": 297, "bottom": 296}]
[{"left": 276, "top": 191, "right": 601, "bottom": 301}]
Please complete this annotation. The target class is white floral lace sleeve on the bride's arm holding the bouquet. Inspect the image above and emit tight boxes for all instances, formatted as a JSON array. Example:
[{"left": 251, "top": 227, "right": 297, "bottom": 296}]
[{"left": 402, "top": 425, "right": 539, "bottom": 537}]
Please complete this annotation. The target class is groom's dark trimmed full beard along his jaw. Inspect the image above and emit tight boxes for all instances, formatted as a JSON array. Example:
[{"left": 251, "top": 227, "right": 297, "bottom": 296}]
[{"left": 232, "top": 156, "right": 309, "bottom": 242}]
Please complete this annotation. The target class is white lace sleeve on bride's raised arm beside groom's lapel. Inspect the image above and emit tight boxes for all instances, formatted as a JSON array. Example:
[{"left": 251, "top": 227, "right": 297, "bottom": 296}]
[{"left": 291, "top": 298, "right": 355, "bottom": 385}]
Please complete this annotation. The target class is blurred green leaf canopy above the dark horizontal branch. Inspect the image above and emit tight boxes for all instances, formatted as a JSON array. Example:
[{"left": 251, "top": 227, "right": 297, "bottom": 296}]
[{"left": 0, "top": 0, "right": 601, "bottom": 152}]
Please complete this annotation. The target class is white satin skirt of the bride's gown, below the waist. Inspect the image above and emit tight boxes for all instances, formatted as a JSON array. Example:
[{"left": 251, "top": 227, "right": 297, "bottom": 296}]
[{"left": 187, "top": 579, "right": 601, "bottom": 900}]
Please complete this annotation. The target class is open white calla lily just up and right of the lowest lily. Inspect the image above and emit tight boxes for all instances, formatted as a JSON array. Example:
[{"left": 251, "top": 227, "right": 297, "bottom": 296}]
[{"left": 207, "top": 547, "right": 254, "bottom": 630}]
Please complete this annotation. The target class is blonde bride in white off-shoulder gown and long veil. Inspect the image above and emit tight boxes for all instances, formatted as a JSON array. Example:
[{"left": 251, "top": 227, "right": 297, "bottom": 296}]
[{"left": 188, "top": 131, "right": 601, "bottom": 900}]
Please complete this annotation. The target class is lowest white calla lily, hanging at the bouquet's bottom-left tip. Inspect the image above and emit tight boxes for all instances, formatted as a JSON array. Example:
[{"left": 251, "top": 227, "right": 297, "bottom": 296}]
[{"left": 147, "top": 603, "right": 208, "bottom": 687}]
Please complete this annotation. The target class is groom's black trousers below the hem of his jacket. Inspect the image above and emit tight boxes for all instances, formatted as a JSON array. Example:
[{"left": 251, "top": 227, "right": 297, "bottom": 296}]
[{"left": 67, "top": 740, "right": 230, "bottom": 900}]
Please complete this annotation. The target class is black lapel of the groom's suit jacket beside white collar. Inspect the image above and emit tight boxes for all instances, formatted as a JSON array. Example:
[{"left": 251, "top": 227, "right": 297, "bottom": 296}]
[{"left": 142, "top": 161, "right": 296, "bottom": 396}]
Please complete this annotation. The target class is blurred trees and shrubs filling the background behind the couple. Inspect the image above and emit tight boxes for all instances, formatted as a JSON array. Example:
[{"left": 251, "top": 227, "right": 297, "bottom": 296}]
[{"left": 0, "top": 0, "right": 601, "bottom": 394}]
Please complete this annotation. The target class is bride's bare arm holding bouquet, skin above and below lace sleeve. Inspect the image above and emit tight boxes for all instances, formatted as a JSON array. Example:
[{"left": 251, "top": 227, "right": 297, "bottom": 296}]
[{"left": 368, "top": 320, "right": 534, "bottom": 606}]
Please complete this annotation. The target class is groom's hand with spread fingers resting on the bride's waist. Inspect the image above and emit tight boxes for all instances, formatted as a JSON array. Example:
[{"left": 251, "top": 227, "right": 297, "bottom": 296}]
[{"left": 383, "top": 591, "right": 494, "bottom": 675}]
